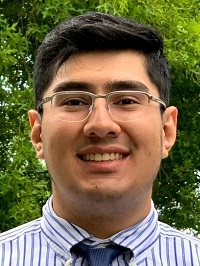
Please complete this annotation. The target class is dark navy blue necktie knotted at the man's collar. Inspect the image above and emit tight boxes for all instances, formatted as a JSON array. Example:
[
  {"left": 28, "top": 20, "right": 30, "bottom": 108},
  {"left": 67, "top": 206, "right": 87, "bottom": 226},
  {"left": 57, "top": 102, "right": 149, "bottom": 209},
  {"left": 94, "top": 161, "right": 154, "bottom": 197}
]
[{"left": 71, "top": 243, "right": 130, "bottom": 266}]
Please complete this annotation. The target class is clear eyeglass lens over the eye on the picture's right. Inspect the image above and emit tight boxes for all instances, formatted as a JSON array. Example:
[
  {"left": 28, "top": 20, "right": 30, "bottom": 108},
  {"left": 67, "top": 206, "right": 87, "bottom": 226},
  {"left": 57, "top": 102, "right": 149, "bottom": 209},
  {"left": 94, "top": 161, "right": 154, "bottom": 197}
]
[{"left": 108, "top": 92, "right": 148, "bottom": 122}]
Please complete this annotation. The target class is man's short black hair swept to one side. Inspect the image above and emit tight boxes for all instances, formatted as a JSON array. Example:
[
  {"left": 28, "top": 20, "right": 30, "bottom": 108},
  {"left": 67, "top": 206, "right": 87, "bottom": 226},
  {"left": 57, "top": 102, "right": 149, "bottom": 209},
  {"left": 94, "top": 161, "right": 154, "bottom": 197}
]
[{"left": 34, "top": 12, "right": 170, "bottom": 109}]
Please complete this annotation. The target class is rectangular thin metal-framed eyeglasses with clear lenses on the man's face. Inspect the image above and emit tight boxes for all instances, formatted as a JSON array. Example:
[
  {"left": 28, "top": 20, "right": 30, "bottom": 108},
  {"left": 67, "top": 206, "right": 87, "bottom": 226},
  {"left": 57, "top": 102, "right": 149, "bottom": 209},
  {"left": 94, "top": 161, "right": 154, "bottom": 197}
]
[{"left": 38, "top": 91, "right": 166, "bottom": 122}]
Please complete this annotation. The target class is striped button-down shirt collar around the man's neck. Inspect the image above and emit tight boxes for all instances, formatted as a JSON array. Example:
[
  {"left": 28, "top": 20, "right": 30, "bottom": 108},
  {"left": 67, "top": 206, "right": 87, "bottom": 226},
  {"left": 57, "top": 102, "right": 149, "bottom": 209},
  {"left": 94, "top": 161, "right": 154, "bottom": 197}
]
[{"left": 41, "top": 196, "right": 160, "bottom": 260}]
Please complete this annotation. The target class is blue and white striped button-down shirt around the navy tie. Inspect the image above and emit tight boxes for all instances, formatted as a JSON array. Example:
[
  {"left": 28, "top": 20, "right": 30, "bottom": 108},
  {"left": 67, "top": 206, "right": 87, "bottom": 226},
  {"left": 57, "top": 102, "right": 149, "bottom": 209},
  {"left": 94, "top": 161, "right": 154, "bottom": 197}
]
[{"left": 0, "top": 197, "right": 200, "bottom": 266}]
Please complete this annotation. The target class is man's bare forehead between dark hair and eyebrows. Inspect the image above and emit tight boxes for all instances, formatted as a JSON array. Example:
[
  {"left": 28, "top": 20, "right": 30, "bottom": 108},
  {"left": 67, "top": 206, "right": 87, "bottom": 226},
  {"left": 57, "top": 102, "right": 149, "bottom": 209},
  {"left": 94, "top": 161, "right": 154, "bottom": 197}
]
[{"left": 46, "top": 50, "right": 158, "bottom": 96}]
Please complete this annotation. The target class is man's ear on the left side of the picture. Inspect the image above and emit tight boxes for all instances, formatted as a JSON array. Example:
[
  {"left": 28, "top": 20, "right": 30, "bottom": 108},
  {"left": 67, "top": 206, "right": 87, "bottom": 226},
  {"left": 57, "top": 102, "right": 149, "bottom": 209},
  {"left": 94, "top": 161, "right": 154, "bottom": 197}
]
[{"left": 28, "top": 110, "right": 44, "bottom": 159}]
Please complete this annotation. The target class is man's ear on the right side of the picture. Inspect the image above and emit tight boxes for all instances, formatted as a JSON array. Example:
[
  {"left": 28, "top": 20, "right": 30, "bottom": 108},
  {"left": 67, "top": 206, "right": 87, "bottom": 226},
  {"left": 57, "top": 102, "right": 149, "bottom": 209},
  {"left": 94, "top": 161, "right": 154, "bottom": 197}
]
[{"left": 162, "top": 106, "right": 178, "bottom": 159}]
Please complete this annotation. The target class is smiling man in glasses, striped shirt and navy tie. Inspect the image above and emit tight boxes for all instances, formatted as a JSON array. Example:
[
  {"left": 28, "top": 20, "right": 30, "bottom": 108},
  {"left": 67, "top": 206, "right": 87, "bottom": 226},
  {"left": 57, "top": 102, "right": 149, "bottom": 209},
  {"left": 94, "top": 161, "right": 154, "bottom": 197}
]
[{"left": 0, "top": 10, "right": 200, "bottom": 266}]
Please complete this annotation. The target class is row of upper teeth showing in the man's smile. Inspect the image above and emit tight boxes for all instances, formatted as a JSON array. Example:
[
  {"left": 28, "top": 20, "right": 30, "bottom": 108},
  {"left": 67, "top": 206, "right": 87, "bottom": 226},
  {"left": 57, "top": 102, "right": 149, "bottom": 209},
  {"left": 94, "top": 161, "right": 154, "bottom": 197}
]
[{"left": 83, "top": 153, "right": 124, "bottom": 162}]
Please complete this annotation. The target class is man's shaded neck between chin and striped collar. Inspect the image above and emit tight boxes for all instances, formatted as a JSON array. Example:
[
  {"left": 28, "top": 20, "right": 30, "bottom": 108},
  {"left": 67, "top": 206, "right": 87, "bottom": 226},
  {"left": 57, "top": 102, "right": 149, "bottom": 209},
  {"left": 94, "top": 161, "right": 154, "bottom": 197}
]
[{"left": 53, "top": 192, "right": 151, "bottom": 239}]
